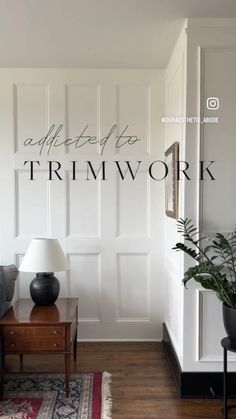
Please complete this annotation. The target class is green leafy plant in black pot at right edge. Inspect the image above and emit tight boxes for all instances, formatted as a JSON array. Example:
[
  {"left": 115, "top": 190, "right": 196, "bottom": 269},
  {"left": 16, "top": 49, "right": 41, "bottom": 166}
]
[{"left": 173, "top": 218, "right": 236, "bottom": 345}]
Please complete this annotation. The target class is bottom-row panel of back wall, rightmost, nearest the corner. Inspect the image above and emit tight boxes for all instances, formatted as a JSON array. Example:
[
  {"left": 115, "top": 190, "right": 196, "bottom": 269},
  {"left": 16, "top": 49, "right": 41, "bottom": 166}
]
[{"left": 117, "top": 253, "right": 150, "bottom": 321}]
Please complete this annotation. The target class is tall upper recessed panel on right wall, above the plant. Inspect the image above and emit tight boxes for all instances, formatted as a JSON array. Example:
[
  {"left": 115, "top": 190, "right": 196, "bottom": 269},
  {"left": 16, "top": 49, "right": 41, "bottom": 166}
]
[{"left": 201, "top": 48, "right": 236, "bottom": 232}]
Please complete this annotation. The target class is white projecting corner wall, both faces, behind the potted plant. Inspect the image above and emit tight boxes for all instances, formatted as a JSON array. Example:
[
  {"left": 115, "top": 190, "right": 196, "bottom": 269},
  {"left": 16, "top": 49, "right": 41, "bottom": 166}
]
[{"left": 165, "top": 19, "right": 236, "bottom": 371}]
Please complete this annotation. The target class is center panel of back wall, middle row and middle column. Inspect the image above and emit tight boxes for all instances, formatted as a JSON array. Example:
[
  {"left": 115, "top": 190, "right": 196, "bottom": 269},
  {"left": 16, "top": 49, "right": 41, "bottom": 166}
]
[{"left": 66, "top": 170, "right": 101, "bottom": 237}]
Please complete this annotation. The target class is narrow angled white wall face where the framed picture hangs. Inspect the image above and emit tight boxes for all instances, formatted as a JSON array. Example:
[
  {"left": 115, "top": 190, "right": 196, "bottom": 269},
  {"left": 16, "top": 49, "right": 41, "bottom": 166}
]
[{"left": 165, "top": 25, "right": 187, "bottom": 364}]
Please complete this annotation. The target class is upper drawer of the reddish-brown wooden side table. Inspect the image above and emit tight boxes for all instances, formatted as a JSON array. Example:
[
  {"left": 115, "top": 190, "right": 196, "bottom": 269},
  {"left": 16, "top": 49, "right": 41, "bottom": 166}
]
[{"left": 4, "top": 326, "right": 65, "bottom": 339}]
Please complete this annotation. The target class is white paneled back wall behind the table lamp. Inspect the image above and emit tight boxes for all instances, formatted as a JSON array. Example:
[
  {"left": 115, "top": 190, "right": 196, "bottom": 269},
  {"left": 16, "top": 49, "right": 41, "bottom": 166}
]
[{"left": 0, "top": 69, "right": 165, "bottom": 340}]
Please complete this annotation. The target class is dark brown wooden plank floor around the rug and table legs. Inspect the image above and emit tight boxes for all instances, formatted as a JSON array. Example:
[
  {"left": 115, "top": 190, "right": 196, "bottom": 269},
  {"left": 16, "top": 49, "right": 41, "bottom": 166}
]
[{"left": 3, "top": 343, "right": 236, "bottom": 419}]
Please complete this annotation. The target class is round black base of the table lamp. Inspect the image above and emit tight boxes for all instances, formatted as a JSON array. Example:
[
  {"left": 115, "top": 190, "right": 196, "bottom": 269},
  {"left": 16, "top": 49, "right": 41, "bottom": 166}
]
[{"left": 30, "top": 272, "right": 60, "bottom": 306}]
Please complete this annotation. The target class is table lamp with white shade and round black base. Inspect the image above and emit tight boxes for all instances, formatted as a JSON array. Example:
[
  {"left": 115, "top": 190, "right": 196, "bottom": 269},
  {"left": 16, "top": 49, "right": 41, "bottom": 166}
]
[{"left": 19, "top": 238, "right": 69, "bottom": 306}]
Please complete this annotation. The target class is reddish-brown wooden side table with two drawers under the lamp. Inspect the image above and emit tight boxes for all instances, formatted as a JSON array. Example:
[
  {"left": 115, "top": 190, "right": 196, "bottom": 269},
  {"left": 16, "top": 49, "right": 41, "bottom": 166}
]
[{"left": 0, "top": 298, "right": 78, "bottom": 396}]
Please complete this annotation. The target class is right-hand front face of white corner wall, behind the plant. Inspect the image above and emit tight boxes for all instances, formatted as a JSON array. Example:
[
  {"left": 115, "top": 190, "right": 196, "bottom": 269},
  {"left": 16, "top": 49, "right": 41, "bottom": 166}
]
[{"left": 183, "top": 19, "right": 236, "bottom": 371}]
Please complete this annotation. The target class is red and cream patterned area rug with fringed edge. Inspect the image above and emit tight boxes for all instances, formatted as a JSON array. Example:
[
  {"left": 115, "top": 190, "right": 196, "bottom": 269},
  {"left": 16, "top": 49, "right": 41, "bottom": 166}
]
[{"left": 0, "top": 372, "right": 112, "bottom": 419}]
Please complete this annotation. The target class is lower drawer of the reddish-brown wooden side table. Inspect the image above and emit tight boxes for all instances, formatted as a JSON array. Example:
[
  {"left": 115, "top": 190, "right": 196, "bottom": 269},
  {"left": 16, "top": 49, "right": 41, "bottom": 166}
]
[{"left": 4, "top": 336, "right": 65, "bottom": 353}]
